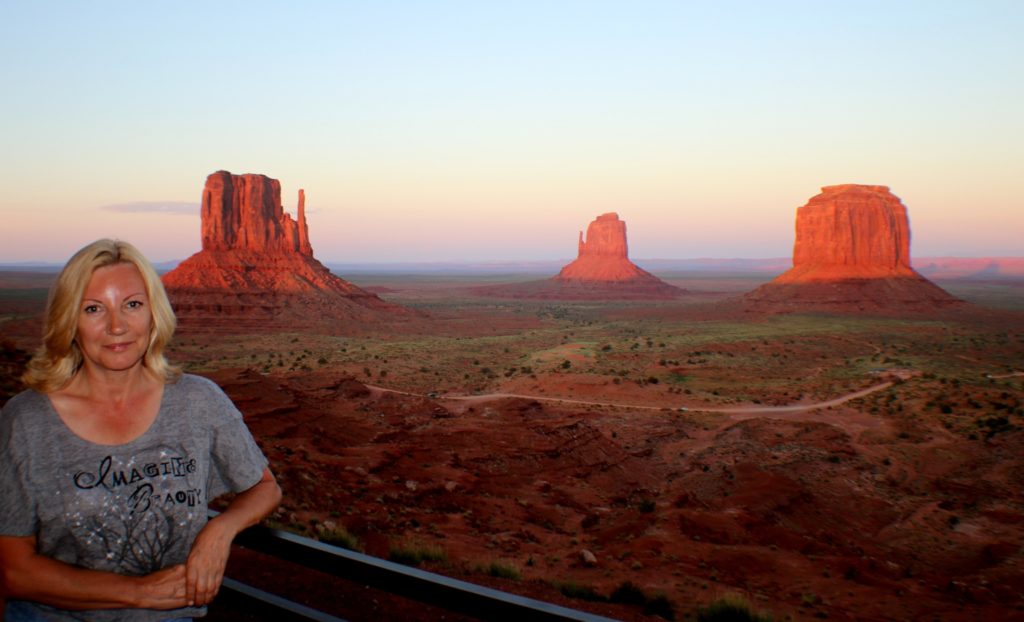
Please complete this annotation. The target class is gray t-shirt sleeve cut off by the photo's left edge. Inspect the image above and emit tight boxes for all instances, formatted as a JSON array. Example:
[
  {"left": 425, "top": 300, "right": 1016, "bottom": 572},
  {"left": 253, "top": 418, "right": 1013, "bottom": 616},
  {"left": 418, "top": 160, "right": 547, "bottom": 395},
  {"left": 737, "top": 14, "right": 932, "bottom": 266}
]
[{"left": 0, "top": 398, "right": 39, "bottom": 537}]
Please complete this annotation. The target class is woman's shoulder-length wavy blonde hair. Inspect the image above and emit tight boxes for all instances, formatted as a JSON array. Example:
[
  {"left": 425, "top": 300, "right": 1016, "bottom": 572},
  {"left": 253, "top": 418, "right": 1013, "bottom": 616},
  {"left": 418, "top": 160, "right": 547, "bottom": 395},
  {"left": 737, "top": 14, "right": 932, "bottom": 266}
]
[{"left": 22, "top": 239, "right": 181, "bottom": 392}]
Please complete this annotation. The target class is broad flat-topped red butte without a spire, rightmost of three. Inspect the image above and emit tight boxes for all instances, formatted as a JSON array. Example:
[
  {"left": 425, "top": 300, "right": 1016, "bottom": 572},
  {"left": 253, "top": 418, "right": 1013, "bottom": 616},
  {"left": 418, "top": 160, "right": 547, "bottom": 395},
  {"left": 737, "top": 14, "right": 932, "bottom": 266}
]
[{"left": 742, "top": 183, "right": 964, "bottom": 314}]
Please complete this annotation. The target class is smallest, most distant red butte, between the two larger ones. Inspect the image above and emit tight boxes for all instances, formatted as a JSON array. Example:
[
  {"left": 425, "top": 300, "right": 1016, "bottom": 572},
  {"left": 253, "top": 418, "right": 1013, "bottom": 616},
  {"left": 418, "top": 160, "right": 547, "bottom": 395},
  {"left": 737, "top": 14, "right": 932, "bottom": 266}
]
[{"left": 474, "top": 212, "right": 685, "bottom": 300}]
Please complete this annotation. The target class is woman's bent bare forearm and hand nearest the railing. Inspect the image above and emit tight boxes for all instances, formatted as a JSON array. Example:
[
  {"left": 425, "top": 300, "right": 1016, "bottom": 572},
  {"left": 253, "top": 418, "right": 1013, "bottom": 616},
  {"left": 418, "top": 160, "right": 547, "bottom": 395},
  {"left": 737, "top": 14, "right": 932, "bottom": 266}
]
[{"left": 185, "top": 468, "right": 281, "bottom": 607}]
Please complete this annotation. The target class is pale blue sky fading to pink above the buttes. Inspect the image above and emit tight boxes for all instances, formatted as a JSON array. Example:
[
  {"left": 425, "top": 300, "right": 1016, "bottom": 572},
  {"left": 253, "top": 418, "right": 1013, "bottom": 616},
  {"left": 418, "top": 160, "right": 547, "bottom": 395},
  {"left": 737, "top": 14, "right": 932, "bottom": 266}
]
[{"left": 0, "top": 0, "right": 1024, "bottom": 263}]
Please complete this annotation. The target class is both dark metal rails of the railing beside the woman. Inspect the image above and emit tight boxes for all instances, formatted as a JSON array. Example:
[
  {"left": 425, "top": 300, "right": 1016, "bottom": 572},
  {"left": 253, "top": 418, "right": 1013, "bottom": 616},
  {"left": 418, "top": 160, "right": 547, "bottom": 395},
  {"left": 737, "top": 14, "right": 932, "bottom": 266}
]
[{"left": 221, "top": 518, "right": 613, "bottom": 622}]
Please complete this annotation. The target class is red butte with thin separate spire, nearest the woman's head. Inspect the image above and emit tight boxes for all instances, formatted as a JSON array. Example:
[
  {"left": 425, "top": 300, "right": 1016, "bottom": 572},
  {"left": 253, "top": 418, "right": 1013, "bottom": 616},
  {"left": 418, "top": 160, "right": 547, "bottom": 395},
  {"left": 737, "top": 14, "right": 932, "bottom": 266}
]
[{"left": 163, "top": 171, "right": 414, "bottom": 333}]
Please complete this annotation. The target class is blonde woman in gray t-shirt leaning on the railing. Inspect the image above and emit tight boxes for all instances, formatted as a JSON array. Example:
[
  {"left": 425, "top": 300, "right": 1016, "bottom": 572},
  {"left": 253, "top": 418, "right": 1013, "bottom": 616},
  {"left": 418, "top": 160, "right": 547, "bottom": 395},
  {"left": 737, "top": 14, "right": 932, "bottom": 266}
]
[{"left": 0, "top": 240, "right": 281, "bottom": 622}]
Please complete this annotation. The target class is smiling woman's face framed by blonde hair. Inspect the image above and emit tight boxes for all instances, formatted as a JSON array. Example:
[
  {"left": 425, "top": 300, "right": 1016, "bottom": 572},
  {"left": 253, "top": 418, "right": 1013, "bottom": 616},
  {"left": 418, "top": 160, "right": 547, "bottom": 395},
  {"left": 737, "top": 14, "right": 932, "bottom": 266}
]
[{"left": 75, "top": 263, "right": 153, "bottom": 371}]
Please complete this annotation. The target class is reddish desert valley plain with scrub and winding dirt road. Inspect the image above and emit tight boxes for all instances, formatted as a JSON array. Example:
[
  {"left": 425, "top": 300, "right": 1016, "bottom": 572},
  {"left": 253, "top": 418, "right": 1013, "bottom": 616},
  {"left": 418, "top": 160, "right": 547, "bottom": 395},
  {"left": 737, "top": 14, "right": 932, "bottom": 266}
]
[{"left": 0, "top": 272, "right": 1024, "bottom": 620}]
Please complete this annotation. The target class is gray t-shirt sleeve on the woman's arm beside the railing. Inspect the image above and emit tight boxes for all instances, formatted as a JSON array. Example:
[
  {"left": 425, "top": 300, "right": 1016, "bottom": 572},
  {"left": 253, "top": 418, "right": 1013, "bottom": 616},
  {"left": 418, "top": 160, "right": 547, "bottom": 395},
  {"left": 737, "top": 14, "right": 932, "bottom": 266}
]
[{"left": 188, "top": 380, "right": 267, "bottom": 500}]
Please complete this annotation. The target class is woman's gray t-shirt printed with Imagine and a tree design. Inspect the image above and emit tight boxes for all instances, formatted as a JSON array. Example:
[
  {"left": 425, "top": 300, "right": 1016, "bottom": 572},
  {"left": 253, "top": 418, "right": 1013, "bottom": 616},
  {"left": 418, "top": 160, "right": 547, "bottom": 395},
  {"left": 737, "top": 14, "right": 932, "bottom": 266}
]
[{"left": 0, "top": 375, "right": 267, "bottom": 620}]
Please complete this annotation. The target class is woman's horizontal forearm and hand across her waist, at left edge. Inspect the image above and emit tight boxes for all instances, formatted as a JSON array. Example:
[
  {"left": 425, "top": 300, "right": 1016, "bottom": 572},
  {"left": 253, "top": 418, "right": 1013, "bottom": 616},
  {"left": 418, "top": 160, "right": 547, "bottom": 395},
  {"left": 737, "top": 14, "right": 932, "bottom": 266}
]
[{"left": 0, "top": 536, "right": 186, "bottom": 610}]
